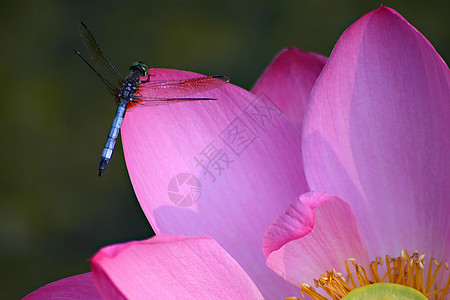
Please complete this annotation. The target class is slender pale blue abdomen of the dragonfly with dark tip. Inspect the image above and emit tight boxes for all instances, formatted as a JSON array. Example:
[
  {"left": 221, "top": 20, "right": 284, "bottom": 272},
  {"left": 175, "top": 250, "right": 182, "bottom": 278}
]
[{"left": 98, "top": 99, "right": 129, "bottom": 176}]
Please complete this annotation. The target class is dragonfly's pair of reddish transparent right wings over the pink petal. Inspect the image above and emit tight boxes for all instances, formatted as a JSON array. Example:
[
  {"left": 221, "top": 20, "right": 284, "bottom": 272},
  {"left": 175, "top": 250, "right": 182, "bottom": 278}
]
[{"left": 135, "top": 76, "right": 230, "bottom": 105}]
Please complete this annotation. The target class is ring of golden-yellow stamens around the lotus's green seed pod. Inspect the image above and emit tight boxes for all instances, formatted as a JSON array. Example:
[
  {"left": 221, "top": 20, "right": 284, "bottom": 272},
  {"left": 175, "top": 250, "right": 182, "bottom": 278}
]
[{"left": 286, "top": 249, "right": 450, "bottom": 300}]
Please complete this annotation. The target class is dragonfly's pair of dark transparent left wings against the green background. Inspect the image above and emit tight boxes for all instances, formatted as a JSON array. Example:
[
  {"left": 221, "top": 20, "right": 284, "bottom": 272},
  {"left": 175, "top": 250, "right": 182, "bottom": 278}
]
[{"left": 77, "top": 22, "right": 124, "bottom": 91}]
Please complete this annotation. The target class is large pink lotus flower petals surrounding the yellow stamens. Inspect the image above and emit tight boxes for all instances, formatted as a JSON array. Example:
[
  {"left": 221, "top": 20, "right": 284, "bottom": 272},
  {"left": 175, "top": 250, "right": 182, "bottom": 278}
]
[{"left": 27, "top": 7, "right": 450, "bottom": 299}]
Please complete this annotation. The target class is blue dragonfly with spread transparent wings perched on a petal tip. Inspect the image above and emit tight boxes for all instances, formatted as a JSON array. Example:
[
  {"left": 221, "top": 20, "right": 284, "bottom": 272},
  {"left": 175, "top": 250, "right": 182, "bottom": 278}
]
[{"left": 74, "top": 22, "right": 230, "bottom": 177}]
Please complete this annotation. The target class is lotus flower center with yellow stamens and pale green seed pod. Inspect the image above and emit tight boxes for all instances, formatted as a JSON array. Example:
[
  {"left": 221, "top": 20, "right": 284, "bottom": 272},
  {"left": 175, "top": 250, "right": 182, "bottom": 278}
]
[{"left": 286, "top": 249, "right": 450, "bottom": 300}]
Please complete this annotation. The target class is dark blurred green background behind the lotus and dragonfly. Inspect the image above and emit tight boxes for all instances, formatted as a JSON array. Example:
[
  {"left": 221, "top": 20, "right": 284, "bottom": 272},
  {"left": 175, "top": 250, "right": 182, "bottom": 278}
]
[{"left": 0, "top": 0, "right": 450, "bottom": 299}]
